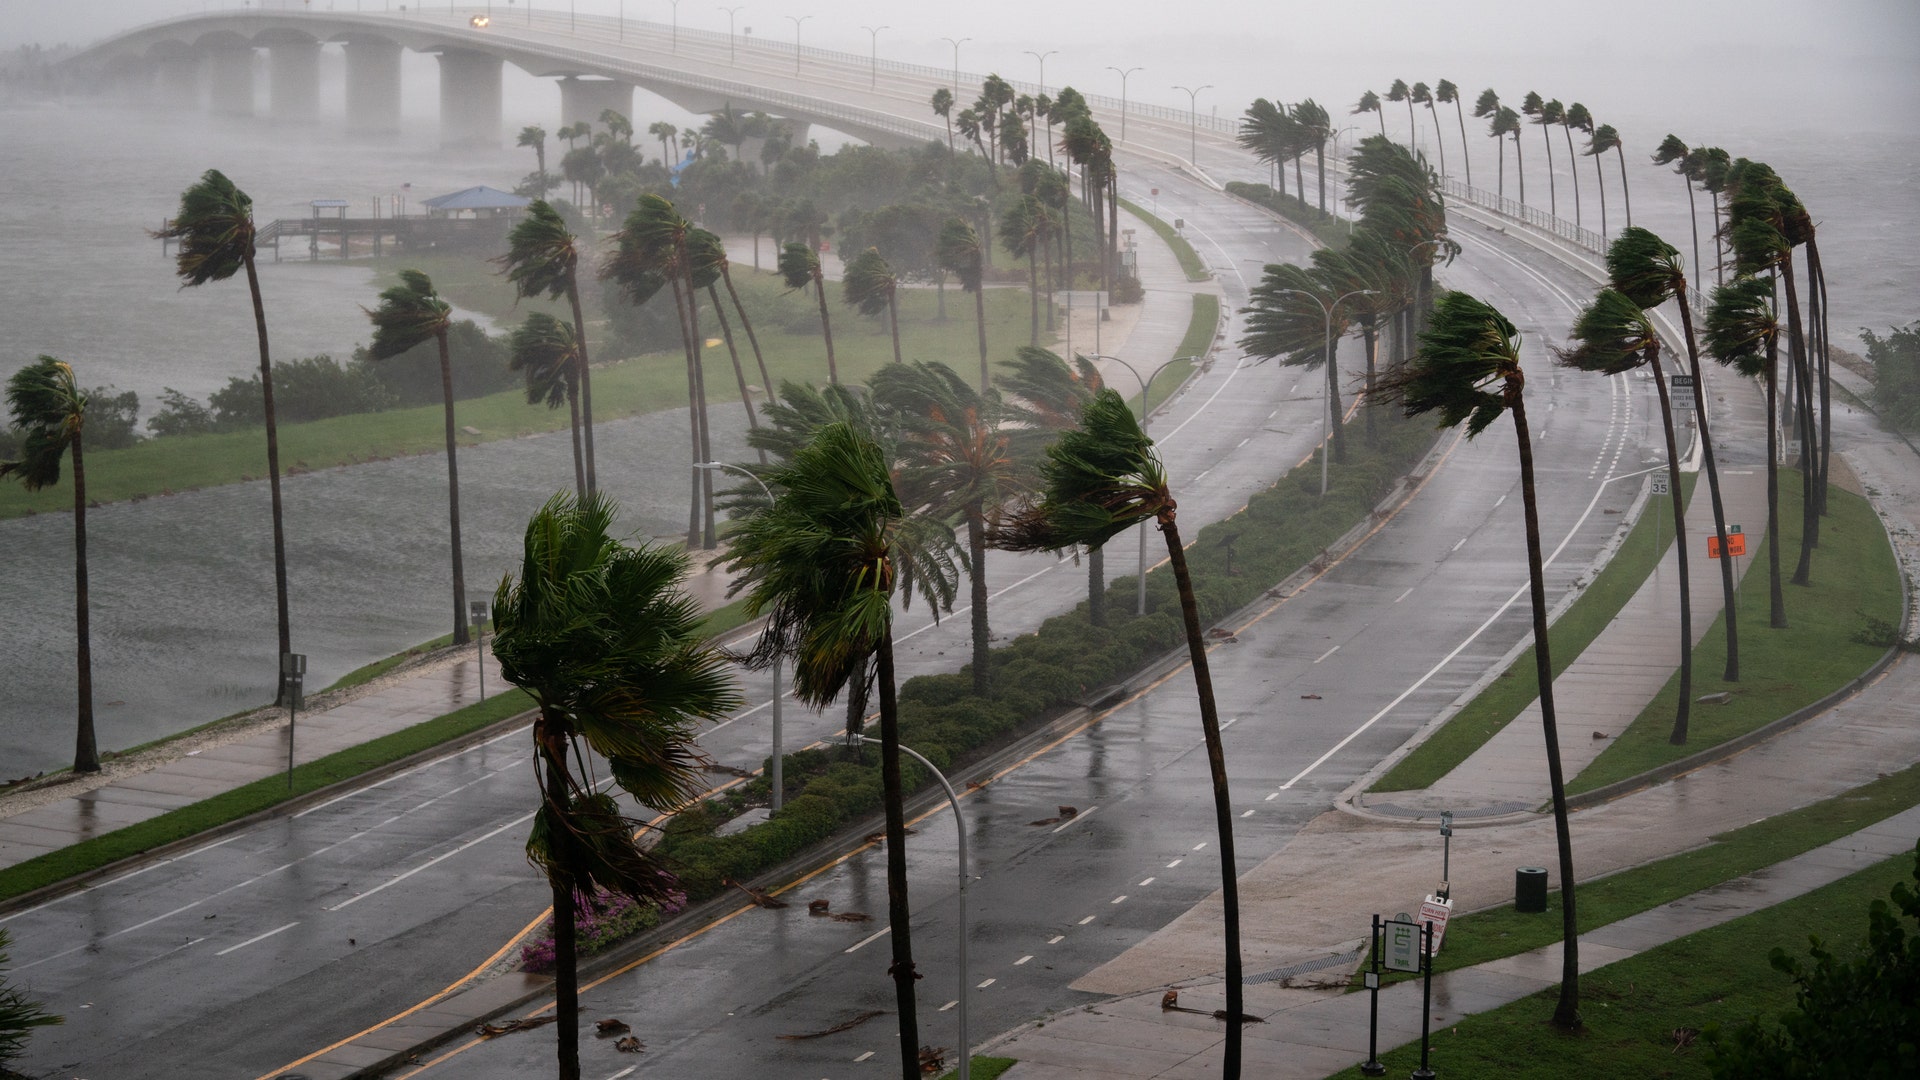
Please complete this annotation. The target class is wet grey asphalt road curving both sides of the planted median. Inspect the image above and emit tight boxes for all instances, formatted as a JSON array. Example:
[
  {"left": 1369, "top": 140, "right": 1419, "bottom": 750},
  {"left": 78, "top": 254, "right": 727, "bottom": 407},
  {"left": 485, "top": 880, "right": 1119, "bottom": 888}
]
[{"left": 6, "top": 151, "right": 1681, "bottom": 1078}]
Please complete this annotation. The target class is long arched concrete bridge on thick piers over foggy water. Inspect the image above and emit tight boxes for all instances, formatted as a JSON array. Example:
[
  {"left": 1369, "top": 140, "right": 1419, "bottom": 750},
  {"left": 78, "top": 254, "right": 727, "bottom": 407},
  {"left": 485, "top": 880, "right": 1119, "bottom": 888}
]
[{"left": 67, "top": 4, "right": 1235, "bottom": 153}]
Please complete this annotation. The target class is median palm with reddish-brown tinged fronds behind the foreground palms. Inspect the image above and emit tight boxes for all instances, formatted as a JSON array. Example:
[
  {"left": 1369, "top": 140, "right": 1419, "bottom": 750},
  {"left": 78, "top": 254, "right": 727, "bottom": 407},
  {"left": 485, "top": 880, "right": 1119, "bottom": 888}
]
[{"left": 872, "top": 361, "right": 1025, "bottom": 698}]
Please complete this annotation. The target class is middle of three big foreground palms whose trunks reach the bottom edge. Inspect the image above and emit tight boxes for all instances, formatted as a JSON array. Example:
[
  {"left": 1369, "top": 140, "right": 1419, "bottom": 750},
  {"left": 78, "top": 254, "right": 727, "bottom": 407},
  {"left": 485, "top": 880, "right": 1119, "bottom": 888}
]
[{"left": 728, "top": 423, "right": 958, "bottom": 1080}]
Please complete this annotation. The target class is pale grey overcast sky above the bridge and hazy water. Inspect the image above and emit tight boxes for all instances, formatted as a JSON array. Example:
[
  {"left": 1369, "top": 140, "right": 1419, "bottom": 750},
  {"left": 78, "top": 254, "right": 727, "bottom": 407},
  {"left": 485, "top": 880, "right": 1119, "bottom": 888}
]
[{"left": 15, "top": 0, "right": 1920, "bottom": 131}]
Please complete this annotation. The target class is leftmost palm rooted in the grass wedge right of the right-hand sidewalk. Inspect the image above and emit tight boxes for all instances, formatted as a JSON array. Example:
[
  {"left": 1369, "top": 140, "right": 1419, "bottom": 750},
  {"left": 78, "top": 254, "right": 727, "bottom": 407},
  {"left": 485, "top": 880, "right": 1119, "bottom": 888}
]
[{"left": 1553, "top": 286, "right": 1697, "bottom": 746}]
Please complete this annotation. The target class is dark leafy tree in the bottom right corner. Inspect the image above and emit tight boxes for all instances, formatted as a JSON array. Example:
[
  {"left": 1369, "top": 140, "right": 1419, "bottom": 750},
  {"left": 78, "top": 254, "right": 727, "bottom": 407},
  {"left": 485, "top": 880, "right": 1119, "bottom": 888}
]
[{"left": 1707, "top": 844, "right": 1920, "bottom": 1080}]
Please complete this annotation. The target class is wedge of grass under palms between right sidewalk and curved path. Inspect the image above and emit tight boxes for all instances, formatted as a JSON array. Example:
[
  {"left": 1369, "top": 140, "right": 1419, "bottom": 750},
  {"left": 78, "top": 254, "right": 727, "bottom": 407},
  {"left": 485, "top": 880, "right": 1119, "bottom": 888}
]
[{"left": 1567, "top": 471, "right": 1901, "bottom": 794}]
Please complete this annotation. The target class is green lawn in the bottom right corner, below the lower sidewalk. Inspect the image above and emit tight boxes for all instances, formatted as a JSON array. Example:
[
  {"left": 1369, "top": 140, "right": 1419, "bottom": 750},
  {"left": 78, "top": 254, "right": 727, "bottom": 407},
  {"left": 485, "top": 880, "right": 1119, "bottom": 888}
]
[{"left": 1334, "top": 841, "right": 1914, "bottom": 1080}]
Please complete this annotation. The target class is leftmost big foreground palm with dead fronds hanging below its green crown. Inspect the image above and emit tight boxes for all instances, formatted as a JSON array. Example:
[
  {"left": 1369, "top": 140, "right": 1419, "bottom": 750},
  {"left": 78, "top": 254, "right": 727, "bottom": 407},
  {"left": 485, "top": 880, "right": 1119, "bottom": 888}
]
[{"left": 493, "top": 494, "right": 739, "bottom": 1080}]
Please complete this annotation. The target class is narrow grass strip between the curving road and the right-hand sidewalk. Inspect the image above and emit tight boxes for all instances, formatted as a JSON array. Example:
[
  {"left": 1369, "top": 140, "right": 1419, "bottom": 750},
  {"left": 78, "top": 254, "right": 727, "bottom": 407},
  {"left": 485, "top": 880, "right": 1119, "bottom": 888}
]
[{"left": 1369, "top": 473, "right": 1704, "bottom": 792}]
